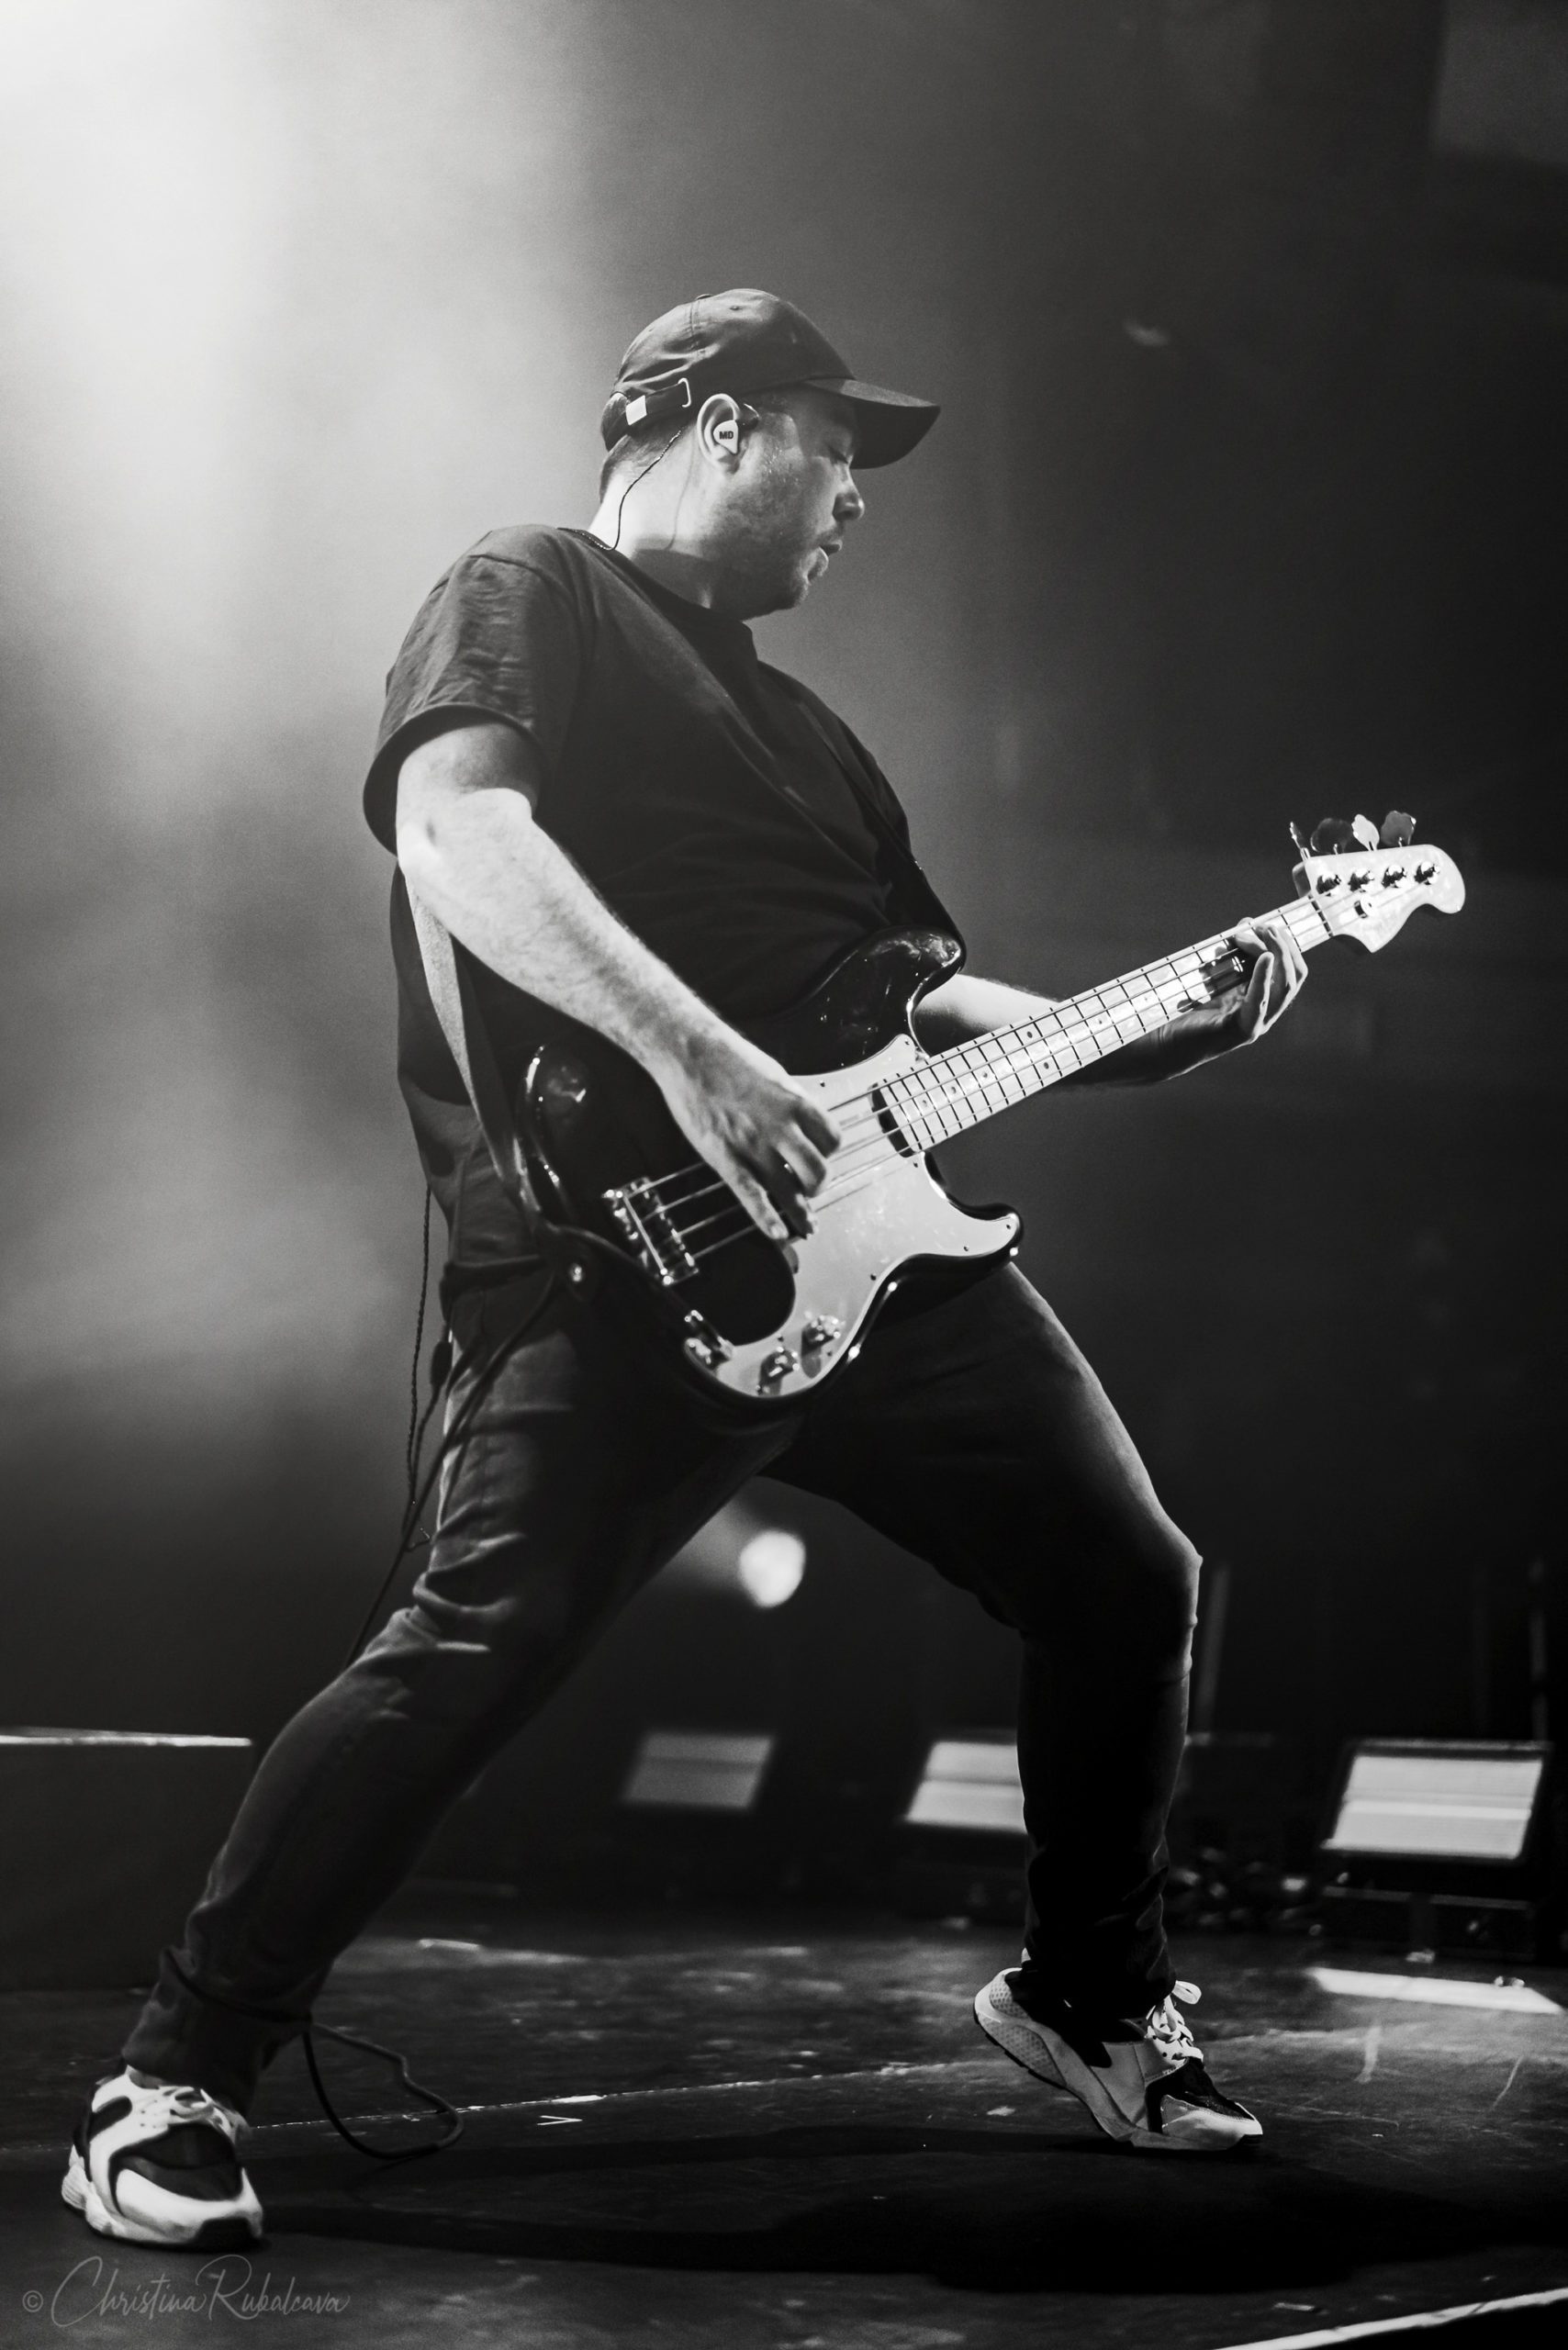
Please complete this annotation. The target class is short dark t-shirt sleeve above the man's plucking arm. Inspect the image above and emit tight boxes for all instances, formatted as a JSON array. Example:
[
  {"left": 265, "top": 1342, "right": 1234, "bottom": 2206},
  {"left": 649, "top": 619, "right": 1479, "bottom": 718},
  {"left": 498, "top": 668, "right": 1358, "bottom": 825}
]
[{"left": 364, "top": 547, "right": 586, "bottom": 848}]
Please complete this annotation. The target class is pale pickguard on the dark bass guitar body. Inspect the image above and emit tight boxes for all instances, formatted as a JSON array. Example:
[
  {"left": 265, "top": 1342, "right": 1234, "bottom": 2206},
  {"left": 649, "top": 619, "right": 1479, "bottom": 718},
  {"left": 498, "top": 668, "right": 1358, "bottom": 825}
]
[{"left": 703, "top": 1036, "right": 1020, "bottom": 1401}]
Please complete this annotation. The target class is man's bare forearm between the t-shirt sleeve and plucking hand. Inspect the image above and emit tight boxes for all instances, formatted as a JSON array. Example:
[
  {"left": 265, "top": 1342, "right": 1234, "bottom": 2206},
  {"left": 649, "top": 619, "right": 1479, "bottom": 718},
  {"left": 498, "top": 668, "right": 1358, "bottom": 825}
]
[{"left": 398, "top": 789, "right": 724, "bottom": 1069}]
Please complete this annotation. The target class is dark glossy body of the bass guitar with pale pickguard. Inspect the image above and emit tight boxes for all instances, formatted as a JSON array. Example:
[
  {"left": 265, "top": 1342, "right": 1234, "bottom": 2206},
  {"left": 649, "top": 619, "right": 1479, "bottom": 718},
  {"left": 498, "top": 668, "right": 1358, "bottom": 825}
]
[{"left": 517, "top": 931, "right": 1020, "bottom": 1407}]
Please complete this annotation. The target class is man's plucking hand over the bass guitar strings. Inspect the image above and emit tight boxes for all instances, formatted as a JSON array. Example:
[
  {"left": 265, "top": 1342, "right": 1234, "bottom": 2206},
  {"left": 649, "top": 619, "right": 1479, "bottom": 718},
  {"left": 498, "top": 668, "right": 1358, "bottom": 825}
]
[{"left": 651, "top": 1029, "right": 842, "bottom": 1241}]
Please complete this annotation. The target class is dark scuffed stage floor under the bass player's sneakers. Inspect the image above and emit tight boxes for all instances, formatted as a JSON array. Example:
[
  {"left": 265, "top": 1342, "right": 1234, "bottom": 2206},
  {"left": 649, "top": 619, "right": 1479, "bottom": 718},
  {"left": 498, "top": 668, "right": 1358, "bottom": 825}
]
[{"left": 0, "top": 1889, "right": 1568, "bottom": 2350}]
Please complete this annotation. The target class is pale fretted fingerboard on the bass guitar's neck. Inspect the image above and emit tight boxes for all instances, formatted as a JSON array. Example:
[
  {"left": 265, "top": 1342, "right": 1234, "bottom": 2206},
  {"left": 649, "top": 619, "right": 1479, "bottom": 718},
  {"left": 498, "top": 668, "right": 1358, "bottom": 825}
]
[{"left": 879, "top": 898, "right": 1333, "bottom": 1151}]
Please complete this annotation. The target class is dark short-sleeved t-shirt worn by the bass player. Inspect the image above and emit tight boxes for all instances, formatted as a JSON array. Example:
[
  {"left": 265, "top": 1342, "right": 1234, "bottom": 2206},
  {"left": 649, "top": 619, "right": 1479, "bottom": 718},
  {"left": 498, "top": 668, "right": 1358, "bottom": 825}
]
[{"left": 364, "top": 526, "right": 952, "bottom": 1262}]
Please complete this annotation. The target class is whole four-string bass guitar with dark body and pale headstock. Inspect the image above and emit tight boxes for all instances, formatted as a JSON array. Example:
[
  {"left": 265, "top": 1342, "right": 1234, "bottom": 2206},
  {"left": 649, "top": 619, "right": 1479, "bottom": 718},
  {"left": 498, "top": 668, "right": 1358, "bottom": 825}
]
[{"left": 517, "top": 818, "right": 1464, "bottom": 1407}]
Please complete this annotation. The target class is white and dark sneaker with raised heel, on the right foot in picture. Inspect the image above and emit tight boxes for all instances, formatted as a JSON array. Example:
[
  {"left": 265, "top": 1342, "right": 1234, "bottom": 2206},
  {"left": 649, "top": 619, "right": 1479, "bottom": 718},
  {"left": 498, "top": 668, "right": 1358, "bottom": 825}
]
[{"left": 976, "top": 1969, "right": 1262, "bottom": 2155}]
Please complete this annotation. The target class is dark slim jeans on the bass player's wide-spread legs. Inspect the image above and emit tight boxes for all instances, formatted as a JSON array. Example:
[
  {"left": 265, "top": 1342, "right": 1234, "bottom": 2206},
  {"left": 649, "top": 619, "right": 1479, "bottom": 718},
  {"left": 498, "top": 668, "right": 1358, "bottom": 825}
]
[{"left": 125, "top": 1267, "right": 1199, "bottom": 2110}]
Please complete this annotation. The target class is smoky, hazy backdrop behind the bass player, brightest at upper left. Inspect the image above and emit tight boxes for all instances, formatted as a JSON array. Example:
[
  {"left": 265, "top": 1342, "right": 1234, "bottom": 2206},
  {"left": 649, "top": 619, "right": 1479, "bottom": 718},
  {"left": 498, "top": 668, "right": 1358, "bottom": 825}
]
[{"left": 0, "top": 0, "right": 1568, "bottom": 1795}]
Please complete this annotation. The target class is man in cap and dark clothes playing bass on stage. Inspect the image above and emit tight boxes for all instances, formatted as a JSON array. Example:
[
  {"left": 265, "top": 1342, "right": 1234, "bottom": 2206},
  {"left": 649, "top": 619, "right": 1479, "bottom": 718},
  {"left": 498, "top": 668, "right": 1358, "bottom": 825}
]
[{"left": 66, "top": 289, "right": 1305, "bottom": 2242}]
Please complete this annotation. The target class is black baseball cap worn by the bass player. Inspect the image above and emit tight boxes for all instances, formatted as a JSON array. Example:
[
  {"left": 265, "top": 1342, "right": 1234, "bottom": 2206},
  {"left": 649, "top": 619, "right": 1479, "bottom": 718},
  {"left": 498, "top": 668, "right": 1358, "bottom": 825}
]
[{"left": 599, "top": 286, "right": 938, "bottom": 465}]
